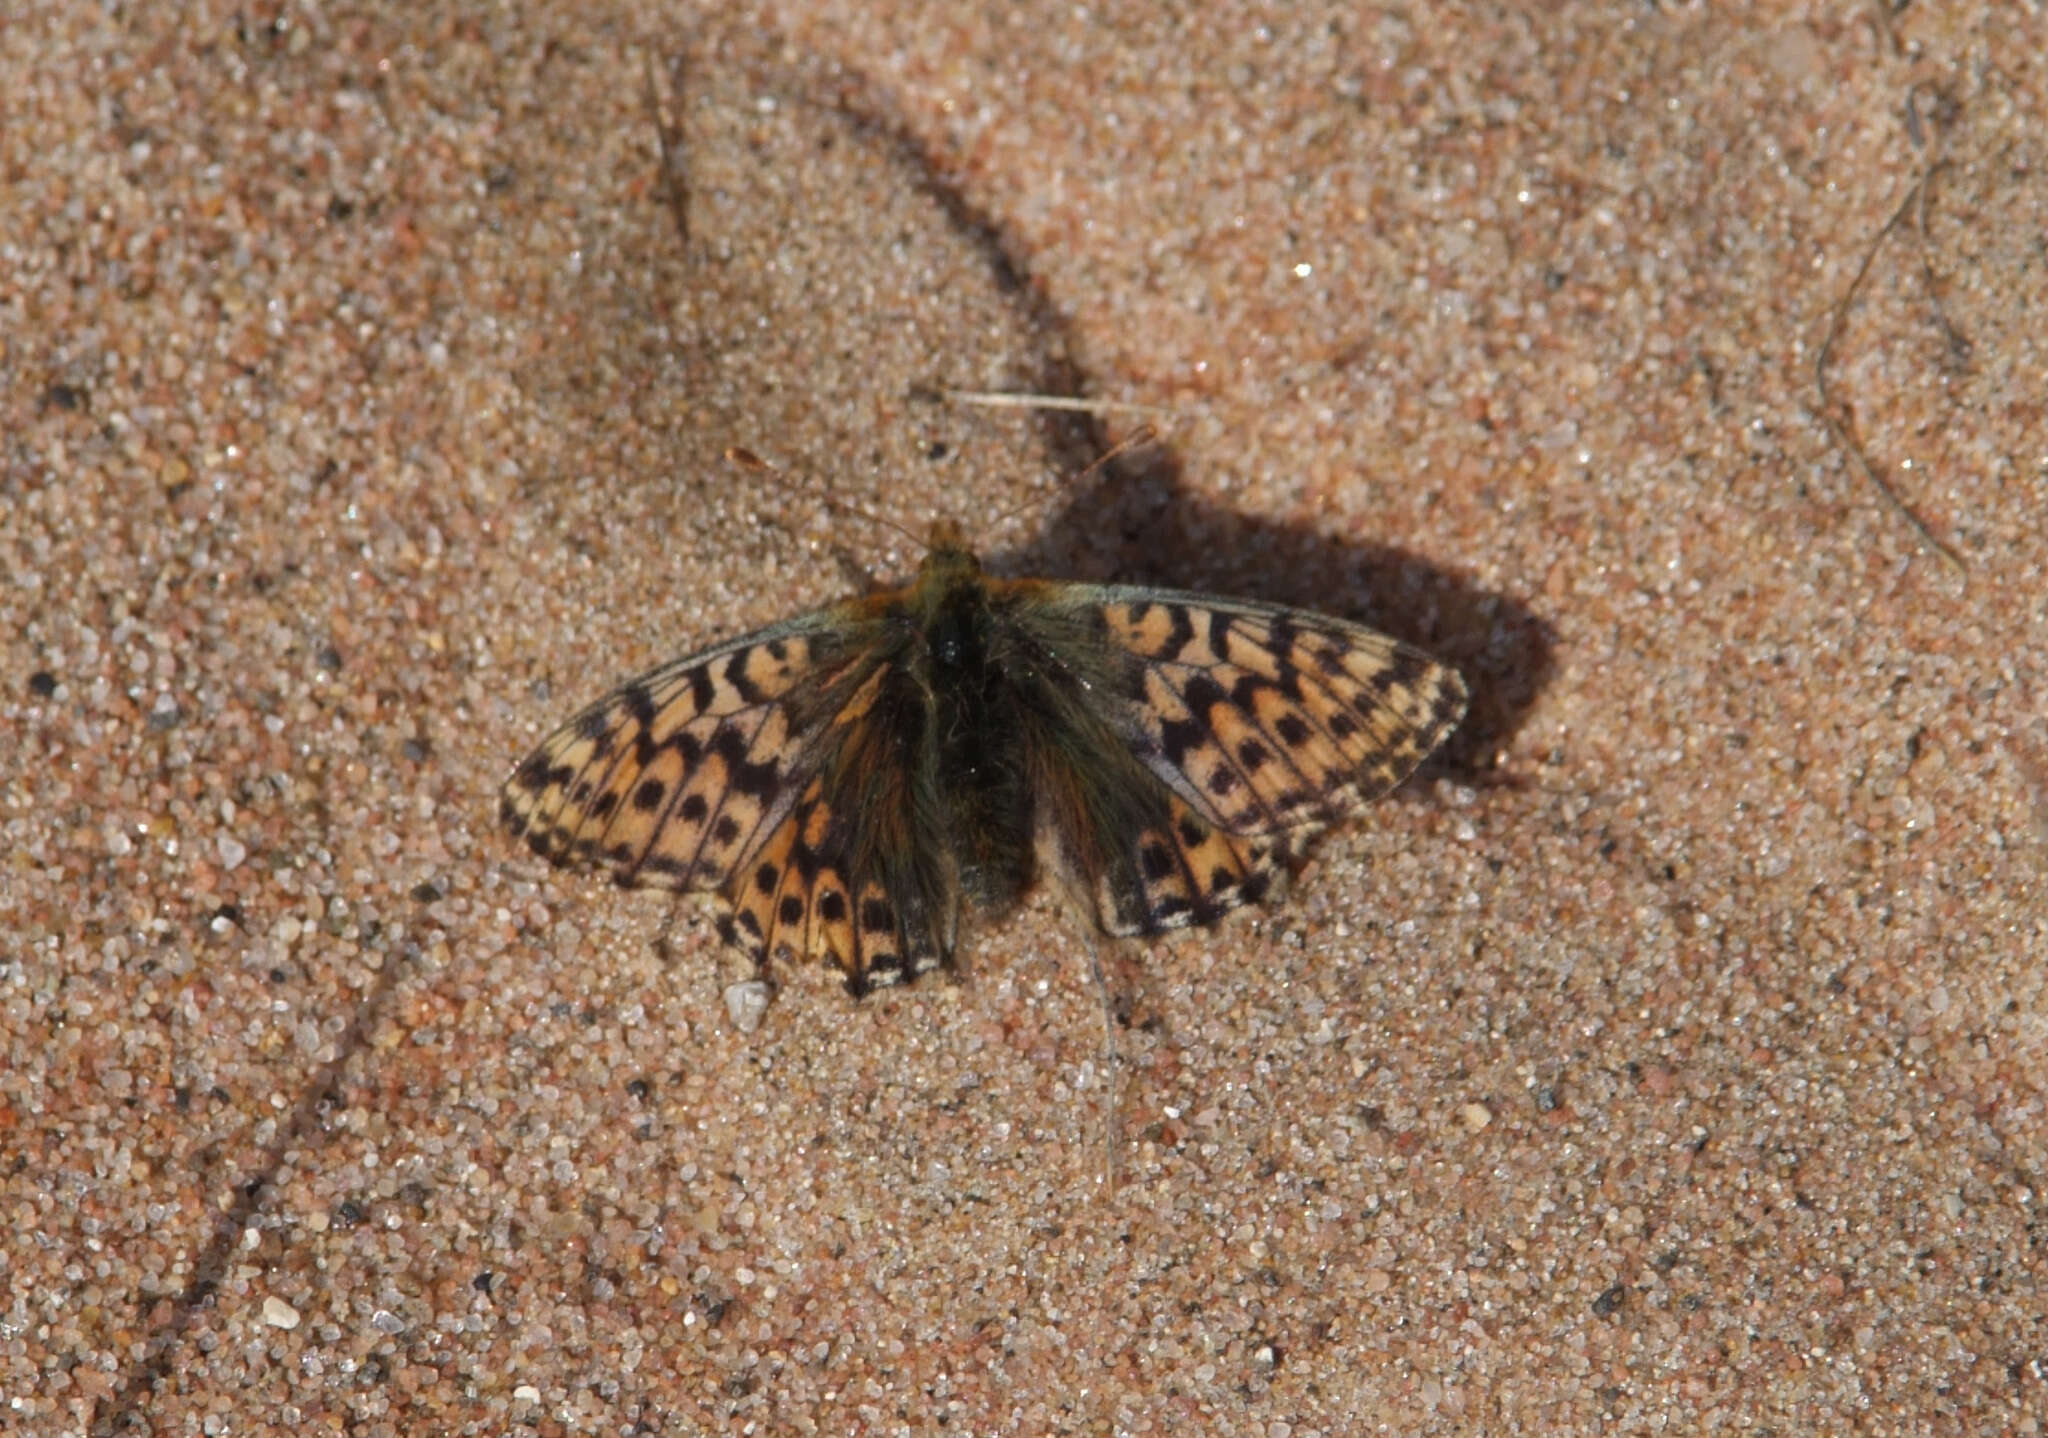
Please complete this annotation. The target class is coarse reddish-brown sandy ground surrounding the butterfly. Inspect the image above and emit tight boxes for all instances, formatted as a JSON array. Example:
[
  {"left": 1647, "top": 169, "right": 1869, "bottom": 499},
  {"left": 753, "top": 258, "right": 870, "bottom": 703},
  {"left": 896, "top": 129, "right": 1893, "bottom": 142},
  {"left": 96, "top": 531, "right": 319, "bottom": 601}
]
[{"left": 0, "top": 0, "right": 2048, "bottom": 1438}]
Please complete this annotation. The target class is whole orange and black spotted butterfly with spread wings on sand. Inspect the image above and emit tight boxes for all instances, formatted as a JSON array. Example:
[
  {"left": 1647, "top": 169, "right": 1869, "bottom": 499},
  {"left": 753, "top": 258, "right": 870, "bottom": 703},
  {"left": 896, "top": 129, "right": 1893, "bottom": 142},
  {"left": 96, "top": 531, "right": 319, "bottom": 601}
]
[{"left": 502, "top": 520, "right": 1466, "bottom": 996}]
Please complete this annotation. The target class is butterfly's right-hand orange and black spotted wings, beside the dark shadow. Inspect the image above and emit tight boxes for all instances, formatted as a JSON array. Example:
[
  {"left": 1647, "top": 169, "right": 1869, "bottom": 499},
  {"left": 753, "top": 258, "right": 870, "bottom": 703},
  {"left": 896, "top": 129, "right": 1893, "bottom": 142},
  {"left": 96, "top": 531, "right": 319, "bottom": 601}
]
[{"left": 1014, "top": 584, "right": 1466, "bottom": 934}]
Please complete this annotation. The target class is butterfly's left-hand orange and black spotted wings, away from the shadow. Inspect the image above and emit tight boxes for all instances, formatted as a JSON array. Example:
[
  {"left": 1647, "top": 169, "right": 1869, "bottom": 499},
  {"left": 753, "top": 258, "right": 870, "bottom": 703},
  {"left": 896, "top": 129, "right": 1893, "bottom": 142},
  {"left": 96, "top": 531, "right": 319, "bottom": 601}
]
[{"left": 500, "top": 596, "right": 958, "bottom": 993}]
